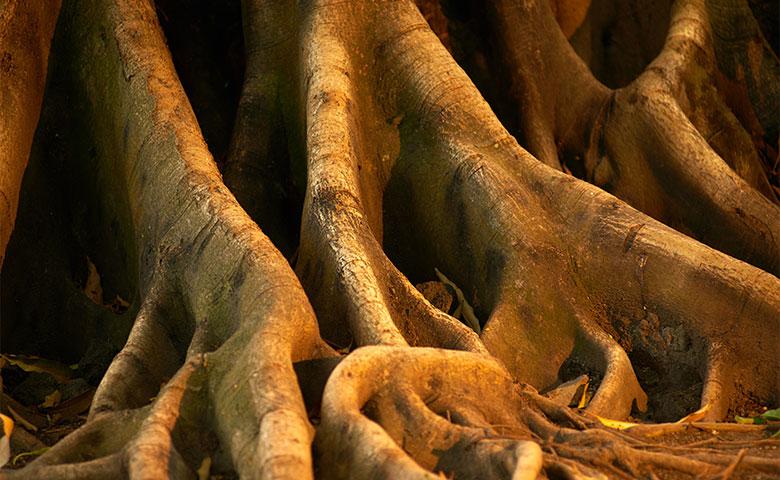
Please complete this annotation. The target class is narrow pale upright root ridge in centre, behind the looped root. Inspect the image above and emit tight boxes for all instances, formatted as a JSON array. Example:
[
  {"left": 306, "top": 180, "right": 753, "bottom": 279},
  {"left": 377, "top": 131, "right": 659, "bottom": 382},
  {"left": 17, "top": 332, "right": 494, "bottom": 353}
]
[{"left": 297, "top": 0, "right": 485, "bottom": 352}]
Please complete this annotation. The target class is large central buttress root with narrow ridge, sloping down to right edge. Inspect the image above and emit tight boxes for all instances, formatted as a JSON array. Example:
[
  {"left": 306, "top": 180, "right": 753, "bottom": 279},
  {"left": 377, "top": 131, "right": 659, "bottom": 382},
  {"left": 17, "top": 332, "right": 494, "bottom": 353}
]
[{"left": 278, "top": 3, "right": 780, "bottom": 418}]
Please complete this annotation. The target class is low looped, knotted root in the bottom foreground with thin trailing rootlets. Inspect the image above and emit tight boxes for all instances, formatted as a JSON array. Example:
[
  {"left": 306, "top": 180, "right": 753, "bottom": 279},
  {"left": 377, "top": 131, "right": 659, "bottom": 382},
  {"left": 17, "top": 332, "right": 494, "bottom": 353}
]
[{"left": 317, "top": 347, "right": 780, "bottom": 479}]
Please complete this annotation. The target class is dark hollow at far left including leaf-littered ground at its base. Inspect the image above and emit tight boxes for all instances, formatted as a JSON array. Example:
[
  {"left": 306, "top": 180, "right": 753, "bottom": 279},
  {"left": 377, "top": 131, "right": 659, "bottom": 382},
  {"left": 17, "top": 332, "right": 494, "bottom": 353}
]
[{"left": 0, "top": 17, "right": 138, "bottom": 458}]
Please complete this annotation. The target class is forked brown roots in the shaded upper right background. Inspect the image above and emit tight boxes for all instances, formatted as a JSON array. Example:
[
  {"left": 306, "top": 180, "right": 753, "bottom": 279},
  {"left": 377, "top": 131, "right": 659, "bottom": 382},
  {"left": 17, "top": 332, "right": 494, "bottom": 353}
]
[{"left": 430, "top": 0, "right": 780, "bottom": 275}]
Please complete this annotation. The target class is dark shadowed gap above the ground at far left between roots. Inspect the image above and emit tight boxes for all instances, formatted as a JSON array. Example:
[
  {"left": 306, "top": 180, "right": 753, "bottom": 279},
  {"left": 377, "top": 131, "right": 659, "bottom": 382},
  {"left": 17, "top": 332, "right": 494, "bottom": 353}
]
[{"left": 0, "top": 28, "right": 138, "bottom": 376}]
